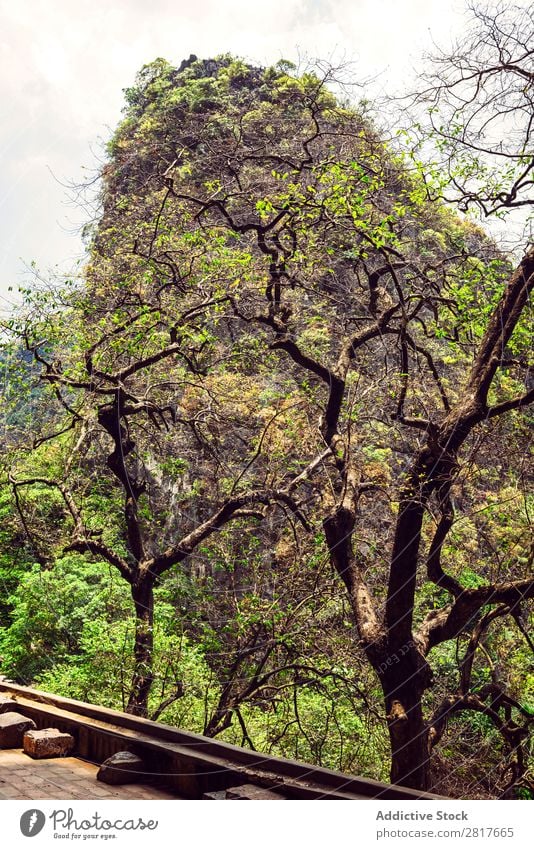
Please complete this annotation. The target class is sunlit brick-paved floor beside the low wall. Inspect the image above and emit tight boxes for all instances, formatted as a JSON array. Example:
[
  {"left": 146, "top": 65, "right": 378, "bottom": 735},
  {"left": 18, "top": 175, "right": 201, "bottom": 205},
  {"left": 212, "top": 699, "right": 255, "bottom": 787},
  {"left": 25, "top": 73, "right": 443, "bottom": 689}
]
[{"left": 0, "top": 749, "right": 178, "bottom": 799}]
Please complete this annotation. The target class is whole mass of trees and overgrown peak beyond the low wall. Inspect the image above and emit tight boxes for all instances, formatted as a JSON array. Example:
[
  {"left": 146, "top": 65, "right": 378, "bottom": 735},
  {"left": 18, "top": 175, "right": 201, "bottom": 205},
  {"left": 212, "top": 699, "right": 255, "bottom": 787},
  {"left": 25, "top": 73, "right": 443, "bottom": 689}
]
[{"left": 0, "top": 3, "right": 534, "bottom": 798}]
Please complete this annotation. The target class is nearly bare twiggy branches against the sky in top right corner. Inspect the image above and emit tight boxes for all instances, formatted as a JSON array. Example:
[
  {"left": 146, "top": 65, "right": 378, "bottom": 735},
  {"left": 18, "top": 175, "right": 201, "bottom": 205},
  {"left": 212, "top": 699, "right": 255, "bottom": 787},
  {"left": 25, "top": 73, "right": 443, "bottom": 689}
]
[{"left": 415, "top": 3, "right": 534, "bottom": 218}]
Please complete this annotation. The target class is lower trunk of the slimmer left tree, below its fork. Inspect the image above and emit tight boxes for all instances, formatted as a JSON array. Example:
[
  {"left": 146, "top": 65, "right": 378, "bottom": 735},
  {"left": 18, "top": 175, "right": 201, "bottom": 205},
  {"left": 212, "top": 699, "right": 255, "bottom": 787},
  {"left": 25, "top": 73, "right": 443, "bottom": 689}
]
[{"left": 126, "top": 580, "right": 154, "bottom": 717}]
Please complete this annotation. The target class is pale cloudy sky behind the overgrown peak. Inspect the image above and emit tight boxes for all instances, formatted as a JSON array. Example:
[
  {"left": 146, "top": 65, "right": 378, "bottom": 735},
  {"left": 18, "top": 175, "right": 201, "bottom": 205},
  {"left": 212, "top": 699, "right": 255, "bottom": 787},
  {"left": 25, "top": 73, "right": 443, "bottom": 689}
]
[{"left": 0, "top": 0, "right": 474, "bottom": 313}]
